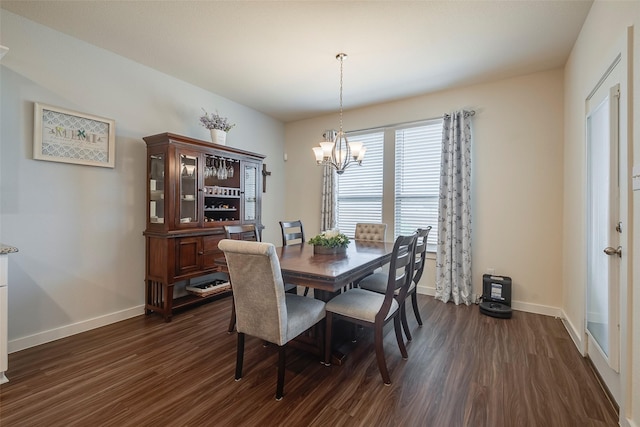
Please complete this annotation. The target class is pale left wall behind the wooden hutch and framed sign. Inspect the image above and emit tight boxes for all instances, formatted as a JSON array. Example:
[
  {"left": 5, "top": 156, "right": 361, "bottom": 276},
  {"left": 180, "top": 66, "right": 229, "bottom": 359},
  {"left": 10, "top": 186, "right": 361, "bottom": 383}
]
[{"left": 0, "top": 10, "right": 284, "bottom": 351}]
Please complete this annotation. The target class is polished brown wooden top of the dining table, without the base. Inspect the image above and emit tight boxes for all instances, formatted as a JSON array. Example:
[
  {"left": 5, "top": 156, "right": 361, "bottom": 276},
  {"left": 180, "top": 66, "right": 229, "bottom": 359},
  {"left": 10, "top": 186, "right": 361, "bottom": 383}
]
[{"left": 276, "top": 240, "right": 393, "bottom": 292}]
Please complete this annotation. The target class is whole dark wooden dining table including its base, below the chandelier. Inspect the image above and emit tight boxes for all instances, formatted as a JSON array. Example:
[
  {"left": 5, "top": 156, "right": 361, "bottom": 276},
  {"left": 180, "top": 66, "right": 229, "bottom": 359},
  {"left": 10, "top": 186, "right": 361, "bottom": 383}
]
[{"left": 216, "top": 240, "right": 393, "bottom": 365}]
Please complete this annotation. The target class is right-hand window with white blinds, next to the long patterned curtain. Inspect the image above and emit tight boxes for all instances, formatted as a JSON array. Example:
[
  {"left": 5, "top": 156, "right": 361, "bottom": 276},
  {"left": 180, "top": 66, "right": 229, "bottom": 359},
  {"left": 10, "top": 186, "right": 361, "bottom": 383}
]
[{"left": 394, "top": 119, "right": 442, "bottom": 251}]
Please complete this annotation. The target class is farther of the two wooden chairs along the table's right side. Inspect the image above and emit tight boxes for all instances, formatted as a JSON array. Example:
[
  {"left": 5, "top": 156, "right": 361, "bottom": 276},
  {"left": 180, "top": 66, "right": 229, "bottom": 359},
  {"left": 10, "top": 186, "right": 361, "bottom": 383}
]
[{"left": 359, "top": 226, "right": 431, "bottom": 341}]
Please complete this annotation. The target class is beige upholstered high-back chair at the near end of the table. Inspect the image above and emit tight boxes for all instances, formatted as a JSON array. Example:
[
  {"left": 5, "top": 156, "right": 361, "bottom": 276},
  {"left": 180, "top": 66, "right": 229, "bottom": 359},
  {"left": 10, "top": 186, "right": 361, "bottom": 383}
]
[{"left": 218, "top": 239, "right": 325, "bottom": 400}]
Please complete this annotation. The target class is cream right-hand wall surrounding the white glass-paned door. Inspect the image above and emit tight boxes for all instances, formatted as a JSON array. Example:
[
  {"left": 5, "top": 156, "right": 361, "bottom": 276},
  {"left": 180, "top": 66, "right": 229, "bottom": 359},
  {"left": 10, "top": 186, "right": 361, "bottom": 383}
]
[{"left": 563, "top": 1, "right": 640, "bottom": 426}]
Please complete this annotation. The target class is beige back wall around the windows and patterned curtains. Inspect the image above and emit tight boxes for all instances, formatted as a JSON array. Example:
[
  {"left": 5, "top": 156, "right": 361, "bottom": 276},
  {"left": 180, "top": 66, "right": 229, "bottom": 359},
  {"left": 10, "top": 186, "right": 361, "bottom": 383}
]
[{"left": 285, "top": 70, "right": 563, "bottom": 315}]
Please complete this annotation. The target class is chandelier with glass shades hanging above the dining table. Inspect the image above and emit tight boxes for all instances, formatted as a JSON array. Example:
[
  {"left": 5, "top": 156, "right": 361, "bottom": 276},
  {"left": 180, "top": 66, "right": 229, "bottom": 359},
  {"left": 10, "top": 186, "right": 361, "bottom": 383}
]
[{"left": 313, "top": 53, "right": 367, "bottom": 175}]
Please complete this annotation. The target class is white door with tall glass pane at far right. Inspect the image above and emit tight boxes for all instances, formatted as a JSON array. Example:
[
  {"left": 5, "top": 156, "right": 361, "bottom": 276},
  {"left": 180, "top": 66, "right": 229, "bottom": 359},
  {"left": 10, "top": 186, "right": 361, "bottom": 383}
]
[{"left": 585, "top": 72, "right": 622, "bottom": 403}]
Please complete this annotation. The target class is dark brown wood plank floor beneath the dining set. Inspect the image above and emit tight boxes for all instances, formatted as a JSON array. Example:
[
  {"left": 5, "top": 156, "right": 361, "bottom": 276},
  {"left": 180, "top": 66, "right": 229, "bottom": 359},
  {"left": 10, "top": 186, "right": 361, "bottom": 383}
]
[{"left": 0, "top": 295, "right": 617, "bottom": 427}]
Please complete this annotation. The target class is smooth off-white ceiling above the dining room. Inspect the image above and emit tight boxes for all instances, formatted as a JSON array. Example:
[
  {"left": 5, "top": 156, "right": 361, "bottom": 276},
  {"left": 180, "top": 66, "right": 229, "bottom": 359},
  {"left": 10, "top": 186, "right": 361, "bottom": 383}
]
[{"left": 0, "top": 0, "right": 592, "bottom": 122}]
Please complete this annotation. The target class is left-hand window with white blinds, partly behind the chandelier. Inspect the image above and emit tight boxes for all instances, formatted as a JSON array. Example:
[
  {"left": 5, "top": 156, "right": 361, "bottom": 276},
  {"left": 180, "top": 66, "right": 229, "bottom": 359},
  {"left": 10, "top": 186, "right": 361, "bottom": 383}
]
[{"left": 336, "top": 130, "right": 384, "bottom": 237}]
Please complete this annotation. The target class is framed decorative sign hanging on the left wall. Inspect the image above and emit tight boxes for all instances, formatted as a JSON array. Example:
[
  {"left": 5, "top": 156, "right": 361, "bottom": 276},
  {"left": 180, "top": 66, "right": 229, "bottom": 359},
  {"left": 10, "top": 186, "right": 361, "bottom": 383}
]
[{"left": 33, "top": 102, "right": 116, "bottom": 168}]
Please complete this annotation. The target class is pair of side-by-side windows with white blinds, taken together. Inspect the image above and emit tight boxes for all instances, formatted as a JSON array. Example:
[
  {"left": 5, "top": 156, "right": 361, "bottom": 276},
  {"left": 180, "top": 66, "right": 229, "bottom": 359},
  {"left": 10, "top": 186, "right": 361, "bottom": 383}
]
[{"left": 337, "top": 119, "right": 442, "bottom": 252}]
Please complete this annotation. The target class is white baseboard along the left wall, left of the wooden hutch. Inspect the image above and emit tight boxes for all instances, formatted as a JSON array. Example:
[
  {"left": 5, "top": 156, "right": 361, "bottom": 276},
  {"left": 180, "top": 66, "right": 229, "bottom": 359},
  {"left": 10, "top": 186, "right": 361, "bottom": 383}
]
[{"left": 8, "top": 305, "right": 144, "bottom": 353}]
